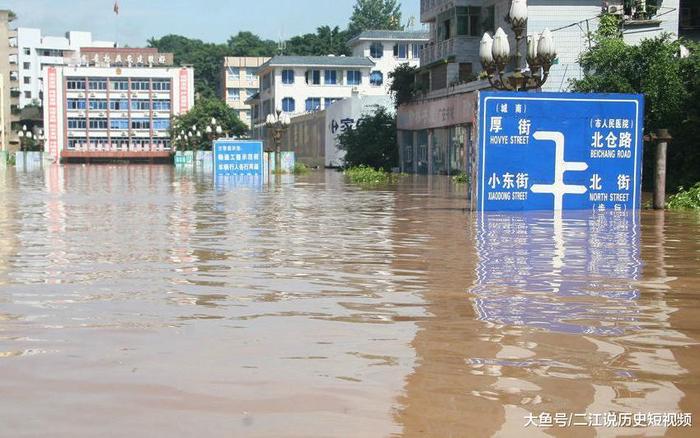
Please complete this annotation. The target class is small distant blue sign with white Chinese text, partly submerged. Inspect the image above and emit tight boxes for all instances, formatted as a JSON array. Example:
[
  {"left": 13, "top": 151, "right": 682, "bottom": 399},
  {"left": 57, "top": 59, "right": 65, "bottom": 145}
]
[{"left": 214, "top": 140, "right": 263, "bottom": 176}]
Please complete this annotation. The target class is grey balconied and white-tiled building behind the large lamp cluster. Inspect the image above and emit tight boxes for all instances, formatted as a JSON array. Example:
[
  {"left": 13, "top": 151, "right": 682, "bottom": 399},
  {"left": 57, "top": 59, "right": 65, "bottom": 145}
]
[{"left": 397, "top": 0, "right": 678, "bottom": 175}]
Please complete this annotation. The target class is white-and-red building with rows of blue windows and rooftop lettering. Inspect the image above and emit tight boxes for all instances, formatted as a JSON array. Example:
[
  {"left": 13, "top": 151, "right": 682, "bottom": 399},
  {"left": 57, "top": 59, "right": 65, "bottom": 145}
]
[{"left": 43, "top": 49, "right": 194, "bottom": 161}]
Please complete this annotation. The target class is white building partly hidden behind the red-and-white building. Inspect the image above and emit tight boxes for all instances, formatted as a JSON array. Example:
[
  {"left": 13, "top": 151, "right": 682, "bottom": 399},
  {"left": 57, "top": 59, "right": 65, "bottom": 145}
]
[{"left": 17, "top": 27, "right": 114, "bottom": 108}]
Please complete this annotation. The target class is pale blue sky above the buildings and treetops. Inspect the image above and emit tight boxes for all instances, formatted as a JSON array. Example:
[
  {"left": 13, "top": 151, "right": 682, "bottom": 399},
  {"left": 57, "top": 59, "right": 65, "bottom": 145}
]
[{"left": 6, "top": 0, "right": 420, "bottom": 47}]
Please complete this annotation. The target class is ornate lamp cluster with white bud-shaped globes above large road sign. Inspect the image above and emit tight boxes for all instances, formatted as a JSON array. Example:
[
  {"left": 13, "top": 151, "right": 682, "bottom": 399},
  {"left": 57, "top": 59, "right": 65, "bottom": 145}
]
[{"left": 479, "top": 0, "right": 557, "bottom": 91}]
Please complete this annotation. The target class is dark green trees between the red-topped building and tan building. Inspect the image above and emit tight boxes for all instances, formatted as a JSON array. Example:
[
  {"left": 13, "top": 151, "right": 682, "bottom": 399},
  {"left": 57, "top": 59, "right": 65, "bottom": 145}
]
[{"left": 148, "top": 35, "right": 231, "bottom": 97}]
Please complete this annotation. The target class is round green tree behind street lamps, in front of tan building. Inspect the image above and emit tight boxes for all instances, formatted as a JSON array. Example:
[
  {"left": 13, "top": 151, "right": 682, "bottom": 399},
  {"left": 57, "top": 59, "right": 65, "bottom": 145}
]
[{"left": 170, "top": 97, "right": 248, "bottom": 150}]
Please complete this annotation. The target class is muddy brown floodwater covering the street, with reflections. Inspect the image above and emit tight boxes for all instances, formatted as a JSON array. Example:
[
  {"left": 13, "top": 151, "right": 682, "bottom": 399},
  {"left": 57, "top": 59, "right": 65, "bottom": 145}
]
[{"left": 0, "top": 166, "right": 700, "bottom": 437}]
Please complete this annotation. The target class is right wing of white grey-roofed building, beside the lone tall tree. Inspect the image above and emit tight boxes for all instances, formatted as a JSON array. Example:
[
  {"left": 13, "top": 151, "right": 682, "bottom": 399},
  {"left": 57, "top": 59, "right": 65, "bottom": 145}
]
[{"left": 348, "top": 30, "right": 430, "bottom": 95}]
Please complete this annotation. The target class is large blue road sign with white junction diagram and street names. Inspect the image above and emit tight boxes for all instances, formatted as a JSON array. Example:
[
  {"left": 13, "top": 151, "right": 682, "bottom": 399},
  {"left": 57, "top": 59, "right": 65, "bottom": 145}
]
[{"left": 477, "top": 92, "right": 644, "bottom": 211}]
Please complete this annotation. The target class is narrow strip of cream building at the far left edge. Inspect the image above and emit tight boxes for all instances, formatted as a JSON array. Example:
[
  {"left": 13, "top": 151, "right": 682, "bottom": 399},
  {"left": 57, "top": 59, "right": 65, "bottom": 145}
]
[{"left": 0, "top": 10, "right": 19, "bottom": 152}]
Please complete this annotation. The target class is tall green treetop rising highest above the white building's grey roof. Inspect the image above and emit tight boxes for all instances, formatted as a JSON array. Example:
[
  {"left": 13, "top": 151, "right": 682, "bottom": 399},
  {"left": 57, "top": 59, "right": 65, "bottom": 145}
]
[{"left": 348, "top": 0, "right": 403, "bottom": 38}]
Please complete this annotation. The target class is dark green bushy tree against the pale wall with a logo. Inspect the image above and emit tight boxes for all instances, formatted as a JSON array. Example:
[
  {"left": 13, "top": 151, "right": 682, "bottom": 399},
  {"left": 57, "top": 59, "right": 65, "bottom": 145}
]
[{"left": 338, "top": 107, "right": 399, "bottom": 171}]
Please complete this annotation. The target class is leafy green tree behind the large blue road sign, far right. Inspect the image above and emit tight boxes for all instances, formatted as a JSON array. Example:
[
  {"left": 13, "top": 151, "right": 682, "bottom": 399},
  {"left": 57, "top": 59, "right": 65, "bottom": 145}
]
[{"left": 572, "top": 17, "right": 700, "bottom": 188}]
